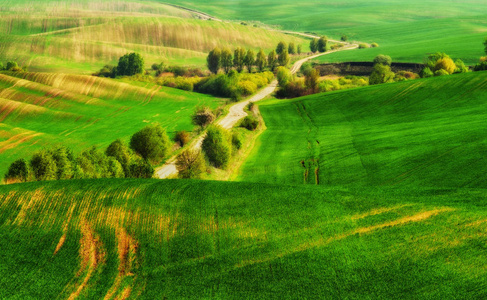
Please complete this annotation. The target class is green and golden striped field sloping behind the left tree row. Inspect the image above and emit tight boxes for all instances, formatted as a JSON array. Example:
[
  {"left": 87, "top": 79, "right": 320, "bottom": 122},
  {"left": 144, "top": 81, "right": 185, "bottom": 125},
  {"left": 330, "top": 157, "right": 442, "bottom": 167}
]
[{"left": 0, "top": 73, "right": 222, "bottom": 176}]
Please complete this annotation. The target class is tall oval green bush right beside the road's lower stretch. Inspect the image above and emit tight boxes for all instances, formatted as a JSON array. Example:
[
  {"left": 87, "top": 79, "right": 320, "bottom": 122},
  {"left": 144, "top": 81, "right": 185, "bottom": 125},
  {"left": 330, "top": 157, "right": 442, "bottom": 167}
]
[{"left": 201, "top": 126, "right": 231, "bottom": 169}]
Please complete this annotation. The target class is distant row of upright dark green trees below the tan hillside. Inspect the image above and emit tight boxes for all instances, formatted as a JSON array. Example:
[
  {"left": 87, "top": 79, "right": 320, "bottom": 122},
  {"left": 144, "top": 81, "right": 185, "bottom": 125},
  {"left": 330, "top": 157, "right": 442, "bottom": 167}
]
[{"left": 206, "top": 42, "right": 294, "bottom": 74}]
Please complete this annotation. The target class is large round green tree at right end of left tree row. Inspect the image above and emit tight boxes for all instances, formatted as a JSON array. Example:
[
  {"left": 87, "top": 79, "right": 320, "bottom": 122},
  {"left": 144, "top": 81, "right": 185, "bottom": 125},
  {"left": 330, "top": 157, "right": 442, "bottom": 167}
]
[{"left": 130, "top": 124, "right": 171, "bottom": 163}]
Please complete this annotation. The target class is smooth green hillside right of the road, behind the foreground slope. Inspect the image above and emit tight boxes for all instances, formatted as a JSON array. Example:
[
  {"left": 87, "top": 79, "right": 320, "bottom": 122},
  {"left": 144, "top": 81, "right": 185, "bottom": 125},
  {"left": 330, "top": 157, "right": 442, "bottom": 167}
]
[{"left": 240, "top": 72, "right": 487, "bottom": 188}]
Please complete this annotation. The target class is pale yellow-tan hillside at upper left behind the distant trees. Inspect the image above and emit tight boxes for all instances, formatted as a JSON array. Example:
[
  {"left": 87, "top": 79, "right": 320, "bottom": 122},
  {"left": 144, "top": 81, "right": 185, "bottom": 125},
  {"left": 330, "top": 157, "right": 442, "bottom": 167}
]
[{"left": 0, "top": 0, "right": 307, "bottom": 73}]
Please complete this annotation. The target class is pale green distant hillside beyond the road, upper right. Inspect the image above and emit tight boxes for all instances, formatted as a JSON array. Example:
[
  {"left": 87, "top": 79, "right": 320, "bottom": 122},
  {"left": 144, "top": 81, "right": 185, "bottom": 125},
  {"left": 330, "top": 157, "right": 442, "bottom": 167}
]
[{"left": 165, "top": 0, "right": 487, "bottom": 63}]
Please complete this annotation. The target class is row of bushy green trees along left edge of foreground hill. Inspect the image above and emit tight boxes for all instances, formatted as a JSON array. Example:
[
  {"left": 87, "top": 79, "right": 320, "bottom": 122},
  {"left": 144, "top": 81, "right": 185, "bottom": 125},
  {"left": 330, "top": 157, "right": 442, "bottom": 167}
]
[{"left": 5, "top": 125, "right": 172, "bottom": 182}]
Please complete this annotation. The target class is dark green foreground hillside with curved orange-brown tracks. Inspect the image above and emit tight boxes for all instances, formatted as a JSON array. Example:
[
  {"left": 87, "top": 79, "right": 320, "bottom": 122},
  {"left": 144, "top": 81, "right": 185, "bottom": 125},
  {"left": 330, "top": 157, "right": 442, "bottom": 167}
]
[{"left": 0, "top": 180, "right": 487, "bottom": 299}]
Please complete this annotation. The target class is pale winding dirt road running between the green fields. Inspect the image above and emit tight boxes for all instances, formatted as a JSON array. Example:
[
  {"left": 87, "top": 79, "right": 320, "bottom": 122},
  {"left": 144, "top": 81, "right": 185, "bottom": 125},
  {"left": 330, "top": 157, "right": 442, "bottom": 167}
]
[{"left": 155, "top": 44, "right": 358, "bottom": 179}]
